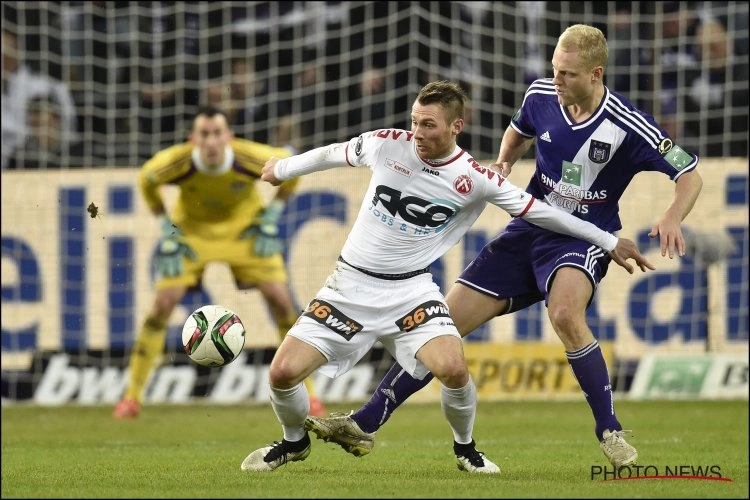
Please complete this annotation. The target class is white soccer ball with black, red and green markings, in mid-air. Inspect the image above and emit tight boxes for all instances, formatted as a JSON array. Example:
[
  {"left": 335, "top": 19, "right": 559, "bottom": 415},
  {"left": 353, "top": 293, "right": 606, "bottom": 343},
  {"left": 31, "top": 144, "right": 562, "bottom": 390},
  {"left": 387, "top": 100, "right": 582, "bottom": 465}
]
[{"left": 182, "top": 305, "right": 245, "bottom": 366}]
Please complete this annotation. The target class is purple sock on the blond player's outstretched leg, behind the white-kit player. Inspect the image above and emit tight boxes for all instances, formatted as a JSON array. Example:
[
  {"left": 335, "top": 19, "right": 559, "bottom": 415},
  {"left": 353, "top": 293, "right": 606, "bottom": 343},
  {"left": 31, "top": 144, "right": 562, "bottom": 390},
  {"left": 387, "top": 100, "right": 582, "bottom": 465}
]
[{"left": 352, "top": 363, "right": 434, "bottom": 432}]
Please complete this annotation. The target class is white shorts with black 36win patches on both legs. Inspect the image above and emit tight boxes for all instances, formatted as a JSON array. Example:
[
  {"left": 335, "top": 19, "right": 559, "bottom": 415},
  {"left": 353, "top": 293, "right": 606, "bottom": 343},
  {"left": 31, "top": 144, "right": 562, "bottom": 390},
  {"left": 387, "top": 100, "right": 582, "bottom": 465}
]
[{"left": 287, "top": 262, "right": 461, "bottom": 380}]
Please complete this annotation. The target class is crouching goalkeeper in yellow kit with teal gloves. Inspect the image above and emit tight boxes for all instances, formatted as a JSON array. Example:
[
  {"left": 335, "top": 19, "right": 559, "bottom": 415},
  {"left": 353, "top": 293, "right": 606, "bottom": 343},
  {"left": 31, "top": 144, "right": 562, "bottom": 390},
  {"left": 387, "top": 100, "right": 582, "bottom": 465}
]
[{"left": 113, "top": 107, "right": 326, "bottom": 419}]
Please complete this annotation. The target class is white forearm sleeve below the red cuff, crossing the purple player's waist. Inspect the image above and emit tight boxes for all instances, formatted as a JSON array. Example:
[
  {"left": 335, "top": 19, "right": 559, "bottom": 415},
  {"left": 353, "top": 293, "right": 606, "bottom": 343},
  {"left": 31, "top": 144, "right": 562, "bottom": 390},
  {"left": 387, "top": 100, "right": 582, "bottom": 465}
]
[{"left": 521, "top": 199, "right": 618, "bottom": 252}]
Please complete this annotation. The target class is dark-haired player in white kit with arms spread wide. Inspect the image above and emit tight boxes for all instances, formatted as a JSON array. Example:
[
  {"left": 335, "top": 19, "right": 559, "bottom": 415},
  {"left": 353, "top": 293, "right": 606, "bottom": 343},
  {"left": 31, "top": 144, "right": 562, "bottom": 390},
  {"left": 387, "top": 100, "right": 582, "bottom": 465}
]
[{"left": 241, "top": 82, "right": 652, "bottom": 473}]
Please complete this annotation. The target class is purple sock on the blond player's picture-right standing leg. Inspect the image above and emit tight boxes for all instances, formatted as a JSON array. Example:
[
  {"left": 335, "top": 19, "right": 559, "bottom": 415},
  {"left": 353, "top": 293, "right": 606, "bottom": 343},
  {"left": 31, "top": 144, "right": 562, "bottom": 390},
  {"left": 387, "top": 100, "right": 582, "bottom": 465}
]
[{"left": 565, "top": 341, "right": 622, "bottom": 441}]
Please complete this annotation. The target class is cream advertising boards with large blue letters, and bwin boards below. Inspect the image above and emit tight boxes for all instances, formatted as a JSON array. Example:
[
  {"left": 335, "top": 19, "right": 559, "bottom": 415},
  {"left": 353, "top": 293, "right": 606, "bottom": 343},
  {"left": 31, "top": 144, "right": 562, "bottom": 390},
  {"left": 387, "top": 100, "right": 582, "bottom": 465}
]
[{"left": 0, "top": 159, "right": 748, "bottom": 404}]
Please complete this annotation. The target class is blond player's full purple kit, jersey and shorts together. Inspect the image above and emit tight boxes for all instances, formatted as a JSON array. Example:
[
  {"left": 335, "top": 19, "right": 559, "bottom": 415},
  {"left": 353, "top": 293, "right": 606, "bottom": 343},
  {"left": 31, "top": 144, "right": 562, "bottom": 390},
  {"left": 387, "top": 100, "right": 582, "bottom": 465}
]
[{"left": 457, "top": 79, "right": 698, "bottom": 306}]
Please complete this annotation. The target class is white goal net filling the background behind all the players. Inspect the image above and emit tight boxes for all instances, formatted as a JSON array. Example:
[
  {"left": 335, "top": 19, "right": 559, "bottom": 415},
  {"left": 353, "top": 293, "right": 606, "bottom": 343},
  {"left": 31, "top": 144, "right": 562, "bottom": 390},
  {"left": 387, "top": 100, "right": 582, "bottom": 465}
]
[{"left": 1, "top": 1, "right": 749, "bottom": 402}]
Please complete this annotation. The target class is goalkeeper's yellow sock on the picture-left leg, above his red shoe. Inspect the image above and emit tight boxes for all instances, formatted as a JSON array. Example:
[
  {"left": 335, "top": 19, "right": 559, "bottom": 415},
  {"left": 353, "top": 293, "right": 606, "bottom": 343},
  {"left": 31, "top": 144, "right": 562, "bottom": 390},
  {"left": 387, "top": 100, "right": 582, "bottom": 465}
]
[{"left": 125, "top": 318, "right": 167, "bottom": 402}]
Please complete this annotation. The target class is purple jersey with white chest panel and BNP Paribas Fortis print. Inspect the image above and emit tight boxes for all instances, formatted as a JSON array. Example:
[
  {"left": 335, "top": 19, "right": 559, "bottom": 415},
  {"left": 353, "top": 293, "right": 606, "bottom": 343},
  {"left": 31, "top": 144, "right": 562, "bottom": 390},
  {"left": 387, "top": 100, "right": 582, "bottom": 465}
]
[{"left": 511, "top": 79, "right": 698, "bottom": 232}]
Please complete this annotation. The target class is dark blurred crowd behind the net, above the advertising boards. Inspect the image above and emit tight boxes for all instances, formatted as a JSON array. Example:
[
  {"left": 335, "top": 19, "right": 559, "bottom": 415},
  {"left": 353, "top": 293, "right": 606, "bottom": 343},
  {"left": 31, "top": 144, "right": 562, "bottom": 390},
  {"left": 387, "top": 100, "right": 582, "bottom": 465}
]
[{"left": 2, "top": 1, "right": 748, "bottom": 171}]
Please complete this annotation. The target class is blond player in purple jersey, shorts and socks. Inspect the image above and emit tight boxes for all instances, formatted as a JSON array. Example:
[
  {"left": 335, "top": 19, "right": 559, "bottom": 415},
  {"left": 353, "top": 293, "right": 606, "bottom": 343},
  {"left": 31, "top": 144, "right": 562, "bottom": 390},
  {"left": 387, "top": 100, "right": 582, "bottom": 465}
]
[{"left": 306, "top": 25, "right": 703, "bottom": 467}]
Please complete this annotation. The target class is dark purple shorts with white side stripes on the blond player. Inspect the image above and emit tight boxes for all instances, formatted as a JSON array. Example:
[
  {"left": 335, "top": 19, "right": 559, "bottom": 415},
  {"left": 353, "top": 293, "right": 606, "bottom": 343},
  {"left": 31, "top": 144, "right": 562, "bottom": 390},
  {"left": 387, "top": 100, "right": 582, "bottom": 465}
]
[{"left": 456, "top": 219, "right": 612, "bottom": 314}]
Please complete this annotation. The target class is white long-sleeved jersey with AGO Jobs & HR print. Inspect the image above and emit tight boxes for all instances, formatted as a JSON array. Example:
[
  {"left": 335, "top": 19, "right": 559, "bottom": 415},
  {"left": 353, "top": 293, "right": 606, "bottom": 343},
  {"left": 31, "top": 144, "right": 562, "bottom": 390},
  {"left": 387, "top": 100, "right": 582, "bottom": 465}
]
[{"left": 274, "top": 129, "right": 617, "bottom": 274}]
